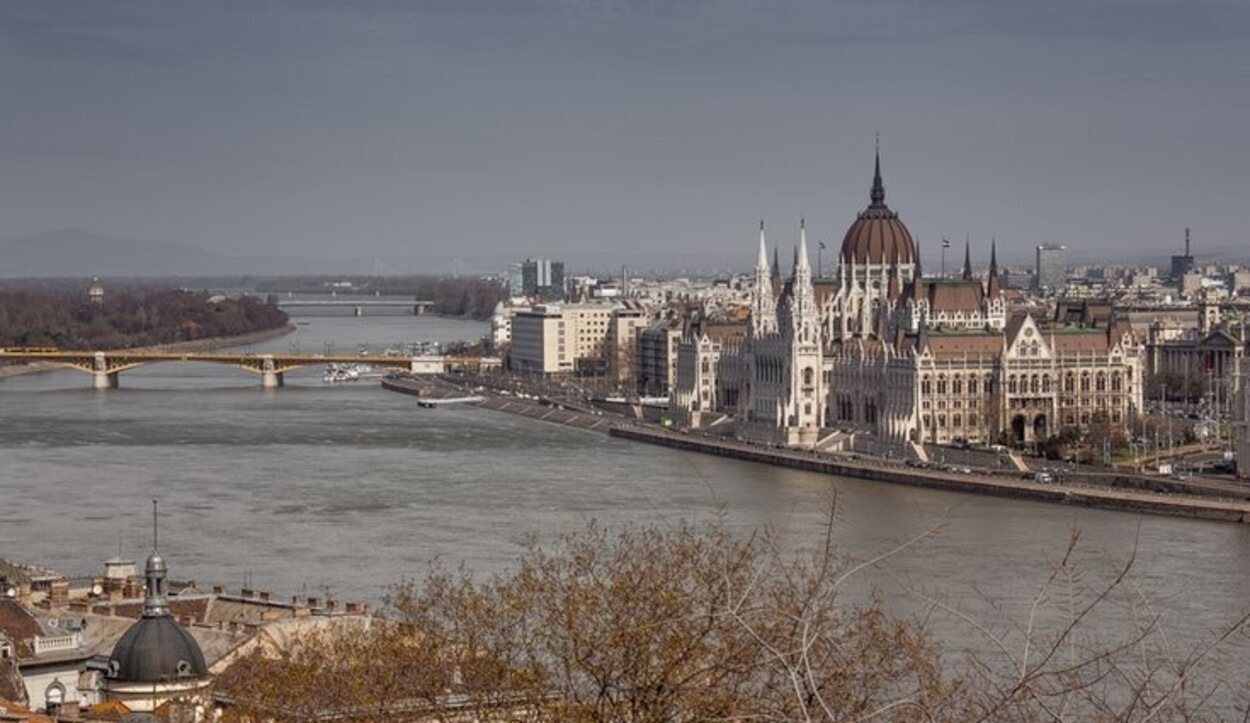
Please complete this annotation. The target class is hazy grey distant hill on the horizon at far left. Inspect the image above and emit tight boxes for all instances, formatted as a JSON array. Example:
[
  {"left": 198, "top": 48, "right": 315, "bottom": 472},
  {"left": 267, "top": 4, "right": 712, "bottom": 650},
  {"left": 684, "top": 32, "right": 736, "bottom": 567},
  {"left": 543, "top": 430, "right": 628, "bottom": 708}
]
[{"left": 0, "top": 229, "right": 241, "bottom": 278}]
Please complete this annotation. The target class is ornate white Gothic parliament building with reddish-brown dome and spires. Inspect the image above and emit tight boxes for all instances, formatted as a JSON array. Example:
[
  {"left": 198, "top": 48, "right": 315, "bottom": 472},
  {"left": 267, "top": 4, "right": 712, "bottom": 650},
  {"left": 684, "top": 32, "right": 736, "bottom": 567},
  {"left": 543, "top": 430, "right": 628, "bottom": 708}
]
[{"left": 674, "top": 150, "right": 1143, "bottom": 447}]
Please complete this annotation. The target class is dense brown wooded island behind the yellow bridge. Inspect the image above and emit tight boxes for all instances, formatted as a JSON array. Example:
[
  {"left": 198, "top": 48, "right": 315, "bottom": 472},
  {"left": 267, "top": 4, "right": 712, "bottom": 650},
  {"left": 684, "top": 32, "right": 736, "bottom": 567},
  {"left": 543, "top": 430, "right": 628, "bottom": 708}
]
[{"left": 0, "top": 289, "right": 288, "bottom": 349}]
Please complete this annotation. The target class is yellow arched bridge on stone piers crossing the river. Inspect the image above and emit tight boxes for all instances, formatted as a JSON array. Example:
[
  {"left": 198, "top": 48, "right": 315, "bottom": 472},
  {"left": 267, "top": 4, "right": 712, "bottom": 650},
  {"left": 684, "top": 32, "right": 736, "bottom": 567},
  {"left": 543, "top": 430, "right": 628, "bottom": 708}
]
[{"left": 0, "top": 349, "right": 483, "bottom": 389}]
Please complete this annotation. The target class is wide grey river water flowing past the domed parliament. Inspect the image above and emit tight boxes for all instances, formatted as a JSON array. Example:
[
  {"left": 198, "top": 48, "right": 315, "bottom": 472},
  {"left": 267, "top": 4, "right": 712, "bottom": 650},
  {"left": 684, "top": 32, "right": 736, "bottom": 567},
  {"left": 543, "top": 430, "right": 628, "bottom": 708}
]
[{"left": 0, "top": 315, "right": 1250, "bottom": 695}]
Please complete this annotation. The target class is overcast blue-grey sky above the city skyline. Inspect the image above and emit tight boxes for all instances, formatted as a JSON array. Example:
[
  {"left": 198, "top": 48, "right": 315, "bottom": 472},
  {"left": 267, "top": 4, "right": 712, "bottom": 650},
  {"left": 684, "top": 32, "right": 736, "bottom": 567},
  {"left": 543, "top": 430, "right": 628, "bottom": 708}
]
[{"left": 0, "top": 0, "right": 1250, "bottom": 268}]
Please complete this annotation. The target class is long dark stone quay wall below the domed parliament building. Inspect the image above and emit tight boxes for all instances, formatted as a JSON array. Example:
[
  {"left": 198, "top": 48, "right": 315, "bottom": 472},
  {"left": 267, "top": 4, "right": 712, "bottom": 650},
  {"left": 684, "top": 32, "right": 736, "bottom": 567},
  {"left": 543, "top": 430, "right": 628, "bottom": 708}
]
[{"left": 609, "top": 425, "right": 1250, "bottom": 523}]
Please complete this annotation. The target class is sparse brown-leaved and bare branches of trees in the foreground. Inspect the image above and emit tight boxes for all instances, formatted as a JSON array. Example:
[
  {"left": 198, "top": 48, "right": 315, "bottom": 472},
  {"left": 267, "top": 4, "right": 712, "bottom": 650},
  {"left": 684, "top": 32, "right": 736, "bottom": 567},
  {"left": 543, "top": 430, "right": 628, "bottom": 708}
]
[{"left": 218, "top": 500, "right": 1248, "bottom": 723}]
